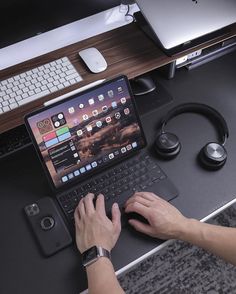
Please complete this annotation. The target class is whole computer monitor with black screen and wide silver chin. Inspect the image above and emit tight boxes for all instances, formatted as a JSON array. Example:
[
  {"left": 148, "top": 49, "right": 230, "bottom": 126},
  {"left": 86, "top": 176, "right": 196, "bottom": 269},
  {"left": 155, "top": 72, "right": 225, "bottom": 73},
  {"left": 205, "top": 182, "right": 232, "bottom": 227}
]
[{"left": 0, "top": 0, "right": 138, "bottom": 70}]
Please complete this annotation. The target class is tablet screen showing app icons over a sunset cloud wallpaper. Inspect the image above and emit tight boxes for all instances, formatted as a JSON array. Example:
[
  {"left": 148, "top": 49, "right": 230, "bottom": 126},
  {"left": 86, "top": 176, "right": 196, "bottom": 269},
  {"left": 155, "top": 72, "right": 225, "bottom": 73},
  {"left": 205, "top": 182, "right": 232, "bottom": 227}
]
[{"left": 25, "top": 76, "right": 148, "bottom": 188}]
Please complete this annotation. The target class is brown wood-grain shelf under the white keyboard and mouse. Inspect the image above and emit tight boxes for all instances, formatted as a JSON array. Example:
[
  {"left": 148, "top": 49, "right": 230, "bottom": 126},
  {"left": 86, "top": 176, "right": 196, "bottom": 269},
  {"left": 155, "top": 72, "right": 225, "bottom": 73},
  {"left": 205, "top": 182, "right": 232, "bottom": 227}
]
[{"left": 0, "top": 23, "right": 236, "bottom": 133}]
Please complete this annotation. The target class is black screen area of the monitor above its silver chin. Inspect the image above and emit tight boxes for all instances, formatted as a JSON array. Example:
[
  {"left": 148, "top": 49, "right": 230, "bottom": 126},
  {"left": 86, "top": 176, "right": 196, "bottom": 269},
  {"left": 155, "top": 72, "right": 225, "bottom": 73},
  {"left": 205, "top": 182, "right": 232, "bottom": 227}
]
[{"left": 0, "top": 0, "right": 120, "bottom": 48}]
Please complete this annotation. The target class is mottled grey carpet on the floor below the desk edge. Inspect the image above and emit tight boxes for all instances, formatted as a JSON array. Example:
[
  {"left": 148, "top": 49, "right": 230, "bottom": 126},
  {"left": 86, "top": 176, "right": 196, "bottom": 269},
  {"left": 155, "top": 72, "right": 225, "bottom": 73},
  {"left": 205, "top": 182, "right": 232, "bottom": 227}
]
[{"left": 119, "top": 205, "right": 236, "bottom": 294}]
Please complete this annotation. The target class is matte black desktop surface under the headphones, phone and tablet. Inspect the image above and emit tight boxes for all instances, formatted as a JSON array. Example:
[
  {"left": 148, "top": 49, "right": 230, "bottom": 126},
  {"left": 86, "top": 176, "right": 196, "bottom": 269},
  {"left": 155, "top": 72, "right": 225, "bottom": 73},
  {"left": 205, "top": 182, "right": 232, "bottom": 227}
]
[{"left": 0, "top": 52, "right": 236, "bottom": 294}]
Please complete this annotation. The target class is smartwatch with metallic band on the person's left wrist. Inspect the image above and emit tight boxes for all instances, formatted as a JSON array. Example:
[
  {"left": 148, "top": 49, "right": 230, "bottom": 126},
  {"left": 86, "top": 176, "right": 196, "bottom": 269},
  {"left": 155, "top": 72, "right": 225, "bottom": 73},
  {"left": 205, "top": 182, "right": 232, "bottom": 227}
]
[{"left": 82, "top": 246, "right": 111, "bottom": 267}]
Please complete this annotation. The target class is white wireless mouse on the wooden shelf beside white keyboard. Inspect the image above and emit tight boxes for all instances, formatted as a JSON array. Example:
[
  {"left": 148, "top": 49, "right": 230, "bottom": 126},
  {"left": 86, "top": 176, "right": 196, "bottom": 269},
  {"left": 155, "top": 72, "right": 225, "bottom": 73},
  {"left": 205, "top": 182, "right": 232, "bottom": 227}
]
[{"left": 79, "top": 47, "right": 107, "bottom": 73}]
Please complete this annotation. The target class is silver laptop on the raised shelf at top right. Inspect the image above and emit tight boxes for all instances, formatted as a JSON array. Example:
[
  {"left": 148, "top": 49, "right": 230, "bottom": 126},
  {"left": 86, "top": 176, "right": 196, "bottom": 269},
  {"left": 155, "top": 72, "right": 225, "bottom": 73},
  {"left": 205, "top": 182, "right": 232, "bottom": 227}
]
[{"left": 135, "top": 0, "right": 236, "bottom": 54}]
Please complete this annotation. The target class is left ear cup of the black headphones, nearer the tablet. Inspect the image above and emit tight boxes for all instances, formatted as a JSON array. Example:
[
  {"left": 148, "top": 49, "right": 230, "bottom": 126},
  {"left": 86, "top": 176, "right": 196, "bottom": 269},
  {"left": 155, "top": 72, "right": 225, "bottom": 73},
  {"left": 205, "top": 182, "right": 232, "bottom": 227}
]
[{"left": 155, "top": 133, "right": 181, "bottom": 159}]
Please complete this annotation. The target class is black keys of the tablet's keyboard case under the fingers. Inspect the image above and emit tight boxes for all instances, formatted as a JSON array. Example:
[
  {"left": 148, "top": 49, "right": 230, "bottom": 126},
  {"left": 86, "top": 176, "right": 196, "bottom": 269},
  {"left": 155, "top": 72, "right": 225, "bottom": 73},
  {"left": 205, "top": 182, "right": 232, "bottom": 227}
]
[{"left": 58, "top": 154, "right": 166, "bottom": 221}]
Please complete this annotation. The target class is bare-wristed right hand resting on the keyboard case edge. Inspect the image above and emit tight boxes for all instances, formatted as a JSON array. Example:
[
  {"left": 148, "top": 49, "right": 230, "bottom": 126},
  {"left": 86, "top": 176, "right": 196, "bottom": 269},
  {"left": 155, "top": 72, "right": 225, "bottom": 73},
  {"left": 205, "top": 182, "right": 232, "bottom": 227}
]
[{"left": 125, "top": 192, "right": 188, "bottom": 240}]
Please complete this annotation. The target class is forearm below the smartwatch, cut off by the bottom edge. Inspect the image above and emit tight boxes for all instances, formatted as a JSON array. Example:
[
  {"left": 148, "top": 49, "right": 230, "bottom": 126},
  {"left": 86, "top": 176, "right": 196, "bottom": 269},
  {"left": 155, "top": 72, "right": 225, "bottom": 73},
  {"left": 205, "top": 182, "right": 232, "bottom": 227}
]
[{"left": 86, "top": 257, "right": 124, "bottom": 294}]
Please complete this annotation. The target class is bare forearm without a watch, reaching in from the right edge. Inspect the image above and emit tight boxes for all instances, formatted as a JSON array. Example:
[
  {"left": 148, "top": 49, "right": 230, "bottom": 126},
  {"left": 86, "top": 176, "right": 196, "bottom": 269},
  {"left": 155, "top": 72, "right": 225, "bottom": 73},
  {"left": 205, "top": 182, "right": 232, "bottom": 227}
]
[{"left": 178, "top": 219, "right": 236, "bottom": 265}]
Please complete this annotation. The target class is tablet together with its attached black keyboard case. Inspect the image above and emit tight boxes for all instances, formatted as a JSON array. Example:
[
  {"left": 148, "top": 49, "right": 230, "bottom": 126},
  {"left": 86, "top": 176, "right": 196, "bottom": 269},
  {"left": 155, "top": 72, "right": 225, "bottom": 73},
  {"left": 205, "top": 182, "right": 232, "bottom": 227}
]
[{"left": 25, "top": 76, "right": 178, "bottom": 225}]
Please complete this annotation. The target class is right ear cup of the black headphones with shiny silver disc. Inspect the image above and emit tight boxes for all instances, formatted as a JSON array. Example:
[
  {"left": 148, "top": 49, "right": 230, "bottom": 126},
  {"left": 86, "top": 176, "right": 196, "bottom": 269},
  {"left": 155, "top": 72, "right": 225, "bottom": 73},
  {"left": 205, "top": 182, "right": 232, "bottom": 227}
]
[{"left": 199, "top": 142, "right": 227, "bottom": 170}]
